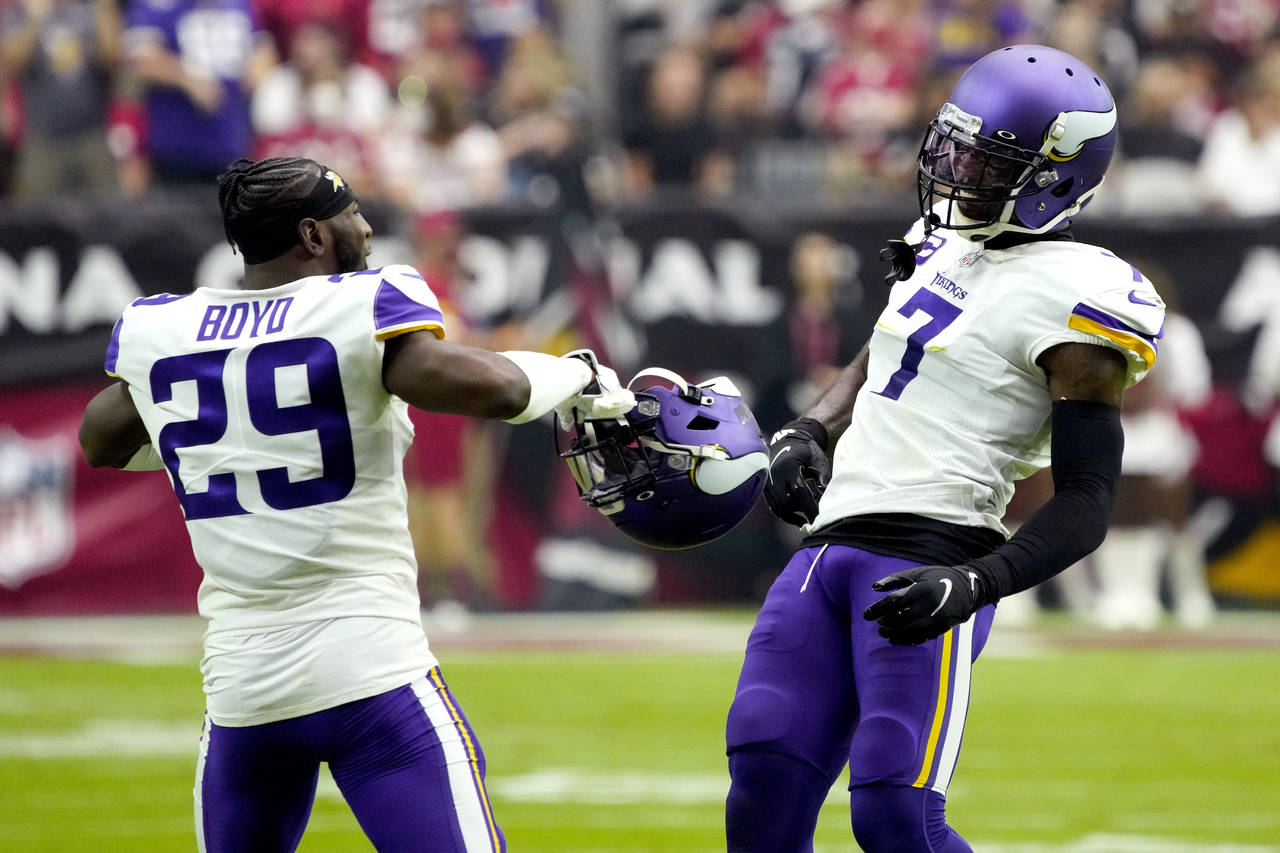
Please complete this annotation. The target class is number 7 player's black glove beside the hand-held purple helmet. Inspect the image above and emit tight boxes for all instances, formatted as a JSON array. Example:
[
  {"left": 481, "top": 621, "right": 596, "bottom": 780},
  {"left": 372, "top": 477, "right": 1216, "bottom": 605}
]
[{"left": 764, "top": 418, "right": 831, "bottom": 528}]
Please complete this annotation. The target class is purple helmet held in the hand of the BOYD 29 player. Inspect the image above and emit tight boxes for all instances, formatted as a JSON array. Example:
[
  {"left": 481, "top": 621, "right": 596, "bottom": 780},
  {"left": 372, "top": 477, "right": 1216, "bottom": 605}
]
[{"left": 557, "top": 368, "right": 769, "bottom": 551}]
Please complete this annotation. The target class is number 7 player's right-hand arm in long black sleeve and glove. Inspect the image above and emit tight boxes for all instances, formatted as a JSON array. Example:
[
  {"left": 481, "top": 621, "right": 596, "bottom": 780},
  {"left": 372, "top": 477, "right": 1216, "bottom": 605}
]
[{"left": 863, "top": 343, "right": 1125, "bottom": 646}]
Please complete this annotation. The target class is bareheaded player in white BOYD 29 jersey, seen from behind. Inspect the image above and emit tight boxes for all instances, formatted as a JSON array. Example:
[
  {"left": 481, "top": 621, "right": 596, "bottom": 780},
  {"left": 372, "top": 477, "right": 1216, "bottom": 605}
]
[{"left": 81, "top": 158, "right": 635, "bottom": 853}]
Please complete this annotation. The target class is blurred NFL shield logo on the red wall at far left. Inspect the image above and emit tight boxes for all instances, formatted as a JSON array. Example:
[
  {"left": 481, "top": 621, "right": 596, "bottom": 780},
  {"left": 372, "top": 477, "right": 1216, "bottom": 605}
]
[{"left": 0, "top": 427, "right": 76, "bottom": 589}]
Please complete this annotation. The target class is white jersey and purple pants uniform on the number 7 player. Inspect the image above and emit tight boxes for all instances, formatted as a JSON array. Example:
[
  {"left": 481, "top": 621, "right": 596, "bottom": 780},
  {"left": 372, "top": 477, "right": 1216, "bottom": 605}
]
[{"left": 727, "top": 212, "right": 1164, "bottom": 829}]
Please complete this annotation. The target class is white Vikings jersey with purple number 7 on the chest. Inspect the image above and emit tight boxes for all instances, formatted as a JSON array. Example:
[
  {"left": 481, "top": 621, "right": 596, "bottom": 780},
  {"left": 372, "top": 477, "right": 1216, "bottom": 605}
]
[{"left": 809, "top": 222, "right": 1165, "bottom": 535}]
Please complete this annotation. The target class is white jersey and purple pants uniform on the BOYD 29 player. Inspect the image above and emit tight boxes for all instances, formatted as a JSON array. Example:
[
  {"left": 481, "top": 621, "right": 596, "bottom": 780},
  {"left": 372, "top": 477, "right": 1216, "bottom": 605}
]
[{"left": 106, "top": 266, "right": 503, "bottom": 853}]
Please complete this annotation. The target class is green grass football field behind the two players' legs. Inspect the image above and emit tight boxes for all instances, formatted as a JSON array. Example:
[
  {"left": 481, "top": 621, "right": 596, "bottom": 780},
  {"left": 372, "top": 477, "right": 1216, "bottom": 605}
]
[{"left": 0, "top": 613, "right": 1280, "bottom": 853}]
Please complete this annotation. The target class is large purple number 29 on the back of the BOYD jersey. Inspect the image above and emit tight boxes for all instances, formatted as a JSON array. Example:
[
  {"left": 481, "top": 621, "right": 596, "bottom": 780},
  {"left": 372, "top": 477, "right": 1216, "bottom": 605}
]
[{"left": 151, "top": 338, "right": 356, "bottom": 521}]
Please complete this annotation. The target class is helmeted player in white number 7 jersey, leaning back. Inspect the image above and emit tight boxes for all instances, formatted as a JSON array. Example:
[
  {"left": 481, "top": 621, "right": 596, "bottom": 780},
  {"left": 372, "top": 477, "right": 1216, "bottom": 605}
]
[{"left": 726, "top": 45, "right": 1164, "bottom": 853}]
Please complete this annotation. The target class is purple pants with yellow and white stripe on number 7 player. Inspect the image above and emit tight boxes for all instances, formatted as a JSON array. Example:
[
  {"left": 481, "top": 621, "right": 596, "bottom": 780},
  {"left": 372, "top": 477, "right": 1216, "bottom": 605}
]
[{"left": 726, "top": 544, "right": 995, "bottom": 853}]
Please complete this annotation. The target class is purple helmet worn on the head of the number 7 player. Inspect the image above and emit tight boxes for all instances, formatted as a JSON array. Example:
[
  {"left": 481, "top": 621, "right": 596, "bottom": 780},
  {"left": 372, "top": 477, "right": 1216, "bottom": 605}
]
[{"left": 918, "top": 45, "right": 1119, "bottom": 241}]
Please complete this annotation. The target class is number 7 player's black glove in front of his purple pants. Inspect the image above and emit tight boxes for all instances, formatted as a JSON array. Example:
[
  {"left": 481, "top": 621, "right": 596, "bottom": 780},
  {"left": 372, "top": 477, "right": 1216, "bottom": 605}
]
[{"left": 863, "top": 565, "right": 988, "bottom": 646}]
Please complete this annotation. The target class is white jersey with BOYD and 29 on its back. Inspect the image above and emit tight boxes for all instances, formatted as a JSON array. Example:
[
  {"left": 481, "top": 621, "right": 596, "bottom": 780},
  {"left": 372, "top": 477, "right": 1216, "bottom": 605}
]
[{"left": 106, "top": 266, "right": 444, "bottom": 725}]
